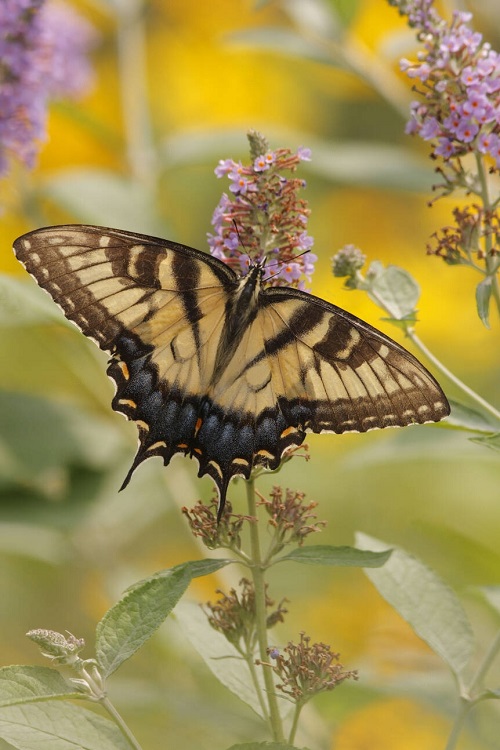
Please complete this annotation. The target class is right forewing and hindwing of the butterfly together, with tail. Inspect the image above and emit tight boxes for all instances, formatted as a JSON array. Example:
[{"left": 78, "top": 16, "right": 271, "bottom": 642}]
[{"left": 181, "top": 287, "right": 449, "bottom": 508}]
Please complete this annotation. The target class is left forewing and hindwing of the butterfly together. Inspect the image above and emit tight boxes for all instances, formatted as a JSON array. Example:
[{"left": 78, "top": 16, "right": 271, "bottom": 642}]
[{"left": 14, "top": 225, "right": 237, "bottom": 494}]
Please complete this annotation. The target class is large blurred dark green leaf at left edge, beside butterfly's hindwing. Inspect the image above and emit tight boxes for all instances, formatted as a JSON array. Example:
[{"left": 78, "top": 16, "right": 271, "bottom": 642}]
[{"left": 0, "top": 391, "right": 122, "bottom": 522}]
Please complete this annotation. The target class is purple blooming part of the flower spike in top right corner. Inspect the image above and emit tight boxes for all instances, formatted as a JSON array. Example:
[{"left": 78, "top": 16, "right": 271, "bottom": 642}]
[{"left": 390, "top": 0, "right": 500, "bottom": 168}]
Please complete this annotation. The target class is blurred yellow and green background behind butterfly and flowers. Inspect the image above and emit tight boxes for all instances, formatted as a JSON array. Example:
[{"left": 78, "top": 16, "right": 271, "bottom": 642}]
[{"left": 0, "top": 0, "right": 500, "bottom": 750}]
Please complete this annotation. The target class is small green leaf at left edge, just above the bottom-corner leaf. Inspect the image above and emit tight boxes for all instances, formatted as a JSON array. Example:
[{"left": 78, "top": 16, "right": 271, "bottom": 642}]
[{"left": 0, "top": 666, "right": 77, "bottom": 707}]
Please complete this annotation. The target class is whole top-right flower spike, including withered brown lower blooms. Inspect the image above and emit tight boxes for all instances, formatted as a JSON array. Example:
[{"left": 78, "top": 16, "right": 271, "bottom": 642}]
[{"left": 389, "top": 0, "right": 500, "bottom": 325}]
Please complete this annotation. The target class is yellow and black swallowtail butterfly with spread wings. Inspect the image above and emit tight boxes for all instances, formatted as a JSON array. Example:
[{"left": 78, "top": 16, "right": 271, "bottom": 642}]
[{"left": 14, "top": 225, "right": 450, "bottom": 517}]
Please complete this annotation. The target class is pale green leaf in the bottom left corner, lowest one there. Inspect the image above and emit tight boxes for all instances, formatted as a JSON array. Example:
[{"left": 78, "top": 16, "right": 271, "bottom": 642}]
[{"left": 0, "top": 701, "right": 130, "bottom": 750}]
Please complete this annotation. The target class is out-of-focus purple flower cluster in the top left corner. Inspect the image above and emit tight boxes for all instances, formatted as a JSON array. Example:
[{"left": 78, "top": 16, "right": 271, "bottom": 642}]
[{"left": 0, "top": 0, "right": 95, "bottom": 175}]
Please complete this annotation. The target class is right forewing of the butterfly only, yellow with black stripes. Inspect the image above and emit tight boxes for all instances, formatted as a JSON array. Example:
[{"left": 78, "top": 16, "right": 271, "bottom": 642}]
[{"left": 261, "top": 287, "right": 450, "bottom": 440}]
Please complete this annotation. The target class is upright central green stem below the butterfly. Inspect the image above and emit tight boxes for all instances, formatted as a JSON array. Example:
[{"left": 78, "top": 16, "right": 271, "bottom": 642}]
[{"left": 246, "top": 479, "right": 284, "bottom": 742}]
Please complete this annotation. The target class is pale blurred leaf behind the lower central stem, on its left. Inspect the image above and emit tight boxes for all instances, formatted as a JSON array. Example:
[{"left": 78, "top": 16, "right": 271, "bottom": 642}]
[{"left": 173, "top": 602, "right": 265, "bottom": 718}]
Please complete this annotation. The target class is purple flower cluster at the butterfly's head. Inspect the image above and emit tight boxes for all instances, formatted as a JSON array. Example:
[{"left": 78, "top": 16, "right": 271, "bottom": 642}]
[{"left": 207, "top": 148, "right": 317, "bottom": 290}]
